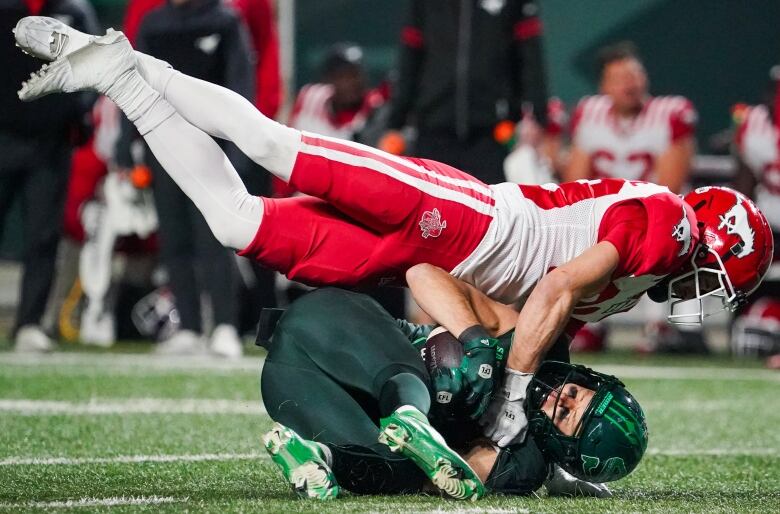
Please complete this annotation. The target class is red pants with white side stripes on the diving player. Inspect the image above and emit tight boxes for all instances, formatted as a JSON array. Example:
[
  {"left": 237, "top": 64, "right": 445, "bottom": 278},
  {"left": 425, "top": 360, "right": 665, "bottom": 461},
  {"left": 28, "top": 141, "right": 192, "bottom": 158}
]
[{"left": 239, "top": 133, "right": 495, "bottom": 286}]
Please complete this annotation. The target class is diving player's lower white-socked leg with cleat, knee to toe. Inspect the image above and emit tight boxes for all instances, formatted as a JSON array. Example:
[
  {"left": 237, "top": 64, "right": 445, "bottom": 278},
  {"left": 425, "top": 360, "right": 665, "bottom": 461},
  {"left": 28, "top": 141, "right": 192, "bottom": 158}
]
[{"left": 17, "top": 32, "right": 263, "bottom": 248}]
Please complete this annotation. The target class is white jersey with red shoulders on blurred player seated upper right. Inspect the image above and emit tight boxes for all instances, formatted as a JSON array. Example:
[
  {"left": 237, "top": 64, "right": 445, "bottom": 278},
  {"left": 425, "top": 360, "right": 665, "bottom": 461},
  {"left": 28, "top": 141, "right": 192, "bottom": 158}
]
[{"left": 571, "top": 95, "right": 696, "bottom": 181}]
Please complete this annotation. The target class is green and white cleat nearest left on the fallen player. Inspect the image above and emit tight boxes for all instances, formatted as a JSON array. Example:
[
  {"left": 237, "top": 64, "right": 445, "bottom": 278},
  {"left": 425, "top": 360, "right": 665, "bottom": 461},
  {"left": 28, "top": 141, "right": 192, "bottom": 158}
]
[{"left": 263, "top": 423, "right": 339, "bottom": 500}]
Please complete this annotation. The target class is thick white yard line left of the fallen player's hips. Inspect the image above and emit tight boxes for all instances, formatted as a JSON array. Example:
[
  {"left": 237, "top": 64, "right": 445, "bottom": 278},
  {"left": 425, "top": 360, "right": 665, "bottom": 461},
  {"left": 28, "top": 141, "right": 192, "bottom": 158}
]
[{"left": 0, "top": 398, "right": 267, "bottom": 416}]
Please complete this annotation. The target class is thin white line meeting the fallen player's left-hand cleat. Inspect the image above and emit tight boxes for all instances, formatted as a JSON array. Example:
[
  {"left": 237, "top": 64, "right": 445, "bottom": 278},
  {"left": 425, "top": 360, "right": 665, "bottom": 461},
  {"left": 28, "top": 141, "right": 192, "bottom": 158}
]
[{"left": 0, "top": 453, "right": 270, "bottom": 466}]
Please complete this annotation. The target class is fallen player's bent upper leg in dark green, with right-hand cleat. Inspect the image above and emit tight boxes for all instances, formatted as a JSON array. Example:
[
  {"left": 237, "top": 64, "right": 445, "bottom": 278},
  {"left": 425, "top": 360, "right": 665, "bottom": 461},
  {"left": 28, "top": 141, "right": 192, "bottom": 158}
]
[{"left": 271, "top": 289, "right": 483, "bottom": 499}]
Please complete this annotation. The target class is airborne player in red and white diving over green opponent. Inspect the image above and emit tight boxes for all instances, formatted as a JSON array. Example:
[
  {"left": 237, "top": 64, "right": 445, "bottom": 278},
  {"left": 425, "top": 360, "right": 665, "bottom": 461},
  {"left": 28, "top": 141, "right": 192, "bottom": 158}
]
[{"left": 15, "top": 17, "right": 773, "bottom": 445}]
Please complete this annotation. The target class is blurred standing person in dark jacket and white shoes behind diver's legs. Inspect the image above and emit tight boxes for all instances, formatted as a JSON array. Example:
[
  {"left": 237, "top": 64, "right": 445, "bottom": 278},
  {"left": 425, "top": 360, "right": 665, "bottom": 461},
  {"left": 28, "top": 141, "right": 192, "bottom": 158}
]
[{"left": 117, "top": 0, "right": 255, "bottom": 357}]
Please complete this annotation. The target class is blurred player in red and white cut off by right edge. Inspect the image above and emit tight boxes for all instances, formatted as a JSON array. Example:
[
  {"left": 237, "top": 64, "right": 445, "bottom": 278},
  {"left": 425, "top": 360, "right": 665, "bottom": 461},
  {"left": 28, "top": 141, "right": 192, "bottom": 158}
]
[{"left": 731, "top": 65, "right": 780, "bottom": 369}]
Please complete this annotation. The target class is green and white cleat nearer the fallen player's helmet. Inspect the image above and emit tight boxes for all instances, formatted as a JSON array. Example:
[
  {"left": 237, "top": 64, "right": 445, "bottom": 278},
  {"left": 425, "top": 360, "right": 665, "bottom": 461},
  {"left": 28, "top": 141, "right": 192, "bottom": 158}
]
[{"left": 379, "top": 407, "right": 485, "bottom": 500}]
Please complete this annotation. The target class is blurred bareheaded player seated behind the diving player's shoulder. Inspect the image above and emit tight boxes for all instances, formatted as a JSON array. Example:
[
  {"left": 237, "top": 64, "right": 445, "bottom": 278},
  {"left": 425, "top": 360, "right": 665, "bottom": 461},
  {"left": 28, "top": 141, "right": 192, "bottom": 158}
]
[{"left": 562, "top": 43, "right": 706, "bottom": 352}]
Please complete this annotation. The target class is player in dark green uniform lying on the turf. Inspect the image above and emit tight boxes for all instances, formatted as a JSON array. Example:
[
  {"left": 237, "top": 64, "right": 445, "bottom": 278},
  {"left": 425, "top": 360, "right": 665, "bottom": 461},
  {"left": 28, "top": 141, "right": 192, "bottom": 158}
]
[{"left": 261, "top": 288, "right": 647, "bottom": 499}]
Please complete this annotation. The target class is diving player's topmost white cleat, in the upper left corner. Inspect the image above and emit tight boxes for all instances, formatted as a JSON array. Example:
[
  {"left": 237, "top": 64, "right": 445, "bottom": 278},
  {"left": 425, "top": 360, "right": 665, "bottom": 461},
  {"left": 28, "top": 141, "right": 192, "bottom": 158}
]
[{"left": 12, "top": 16, "right": 96, "bottom": 61}]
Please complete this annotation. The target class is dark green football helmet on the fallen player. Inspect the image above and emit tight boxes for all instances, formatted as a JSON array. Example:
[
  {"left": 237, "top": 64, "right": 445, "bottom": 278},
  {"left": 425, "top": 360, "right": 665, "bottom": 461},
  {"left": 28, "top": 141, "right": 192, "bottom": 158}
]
[{"left": 526, "top": 361, "right": 647, "bottom": 482}]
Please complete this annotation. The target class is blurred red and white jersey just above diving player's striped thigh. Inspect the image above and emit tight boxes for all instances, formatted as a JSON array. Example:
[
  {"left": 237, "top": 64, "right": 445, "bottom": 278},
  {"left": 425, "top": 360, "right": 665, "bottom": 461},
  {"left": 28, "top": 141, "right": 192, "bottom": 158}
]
[{"left": 288, "top": 84, "right": 385, "bottom": 139}]
